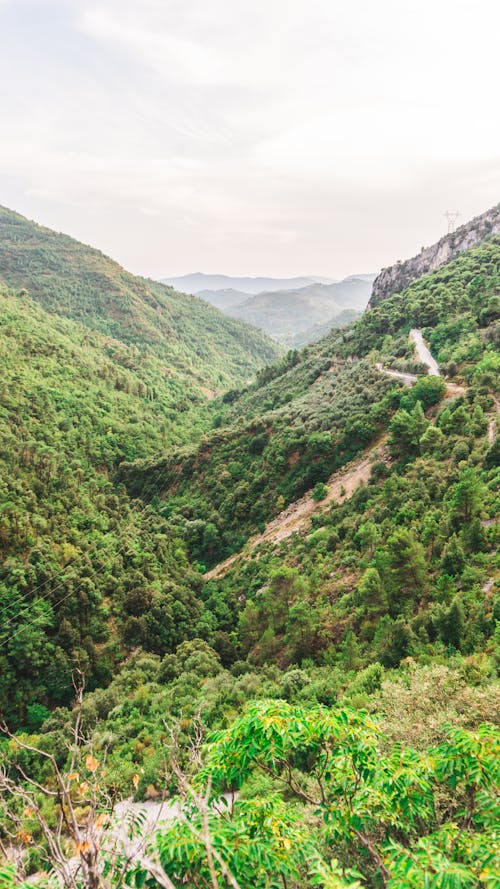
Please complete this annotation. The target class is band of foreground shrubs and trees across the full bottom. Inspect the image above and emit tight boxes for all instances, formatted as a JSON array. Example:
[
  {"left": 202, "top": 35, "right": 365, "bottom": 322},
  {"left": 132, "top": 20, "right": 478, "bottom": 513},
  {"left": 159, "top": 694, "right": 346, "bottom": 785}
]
[{"left": 1, "top": 656, "right": 500, "bottom": 889}]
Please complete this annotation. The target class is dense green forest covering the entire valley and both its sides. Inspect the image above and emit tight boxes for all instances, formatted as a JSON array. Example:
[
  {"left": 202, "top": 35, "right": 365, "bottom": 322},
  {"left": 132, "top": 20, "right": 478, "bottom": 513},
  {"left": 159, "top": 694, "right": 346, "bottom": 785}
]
[{"left": 0, "top": 217, "right": 500, "bottom": 889}]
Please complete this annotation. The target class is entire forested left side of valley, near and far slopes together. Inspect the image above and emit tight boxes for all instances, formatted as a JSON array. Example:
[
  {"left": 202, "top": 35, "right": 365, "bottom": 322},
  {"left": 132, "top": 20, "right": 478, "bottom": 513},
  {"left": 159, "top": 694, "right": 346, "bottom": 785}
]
[{"left": 0, "top": 210, "right": 276, "bottom": 719}]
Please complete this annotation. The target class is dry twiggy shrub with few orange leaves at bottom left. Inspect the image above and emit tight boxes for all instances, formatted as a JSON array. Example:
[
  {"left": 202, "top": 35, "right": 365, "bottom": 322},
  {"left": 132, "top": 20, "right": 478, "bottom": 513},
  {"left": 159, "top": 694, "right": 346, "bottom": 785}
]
[{"left": 0, "top": 681, "right": 254, "bottom": 889}]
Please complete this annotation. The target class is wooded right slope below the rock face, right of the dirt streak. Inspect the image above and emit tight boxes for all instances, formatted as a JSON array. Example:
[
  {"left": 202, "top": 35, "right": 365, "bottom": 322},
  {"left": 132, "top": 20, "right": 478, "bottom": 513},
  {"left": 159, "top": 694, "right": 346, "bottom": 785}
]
[{"left": 197, "top": 238, "right": 500, "bottom": 669}]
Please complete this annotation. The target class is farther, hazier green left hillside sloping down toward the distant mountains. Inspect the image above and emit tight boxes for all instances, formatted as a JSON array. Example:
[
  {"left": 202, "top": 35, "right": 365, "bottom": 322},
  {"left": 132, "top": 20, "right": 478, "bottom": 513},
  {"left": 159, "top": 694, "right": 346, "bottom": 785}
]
[{"left": 0, "top": 208, "right": 278, "bottom": 395}]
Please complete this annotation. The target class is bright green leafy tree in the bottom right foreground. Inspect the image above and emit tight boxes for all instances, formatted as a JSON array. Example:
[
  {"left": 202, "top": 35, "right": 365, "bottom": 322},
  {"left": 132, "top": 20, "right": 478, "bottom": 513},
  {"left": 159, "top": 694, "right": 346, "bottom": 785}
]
[{"left": 202, "top": 701, "right": 500, "bottom": 889}]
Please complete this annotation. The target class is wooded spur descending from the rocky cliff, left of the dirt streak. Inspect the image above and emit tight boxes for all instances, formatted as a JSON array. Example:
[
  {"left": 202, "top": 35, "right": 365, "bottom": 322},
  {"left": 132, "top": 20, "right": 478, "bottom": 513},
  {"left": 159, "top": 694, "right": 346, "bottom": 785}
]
[{"left": 123, "top": 238, "right": 500, "bottom": 564}]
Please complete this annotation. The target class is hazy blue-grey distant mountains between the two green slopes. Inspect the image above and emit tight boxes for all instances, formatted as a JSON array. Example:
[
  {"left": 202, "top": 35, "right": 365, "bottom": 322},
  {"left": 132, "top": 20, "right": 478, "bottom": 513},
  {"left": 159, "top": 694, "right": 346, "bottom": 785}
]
[{"left": 163, "top": 273, "right": 375, "bottom": 345}]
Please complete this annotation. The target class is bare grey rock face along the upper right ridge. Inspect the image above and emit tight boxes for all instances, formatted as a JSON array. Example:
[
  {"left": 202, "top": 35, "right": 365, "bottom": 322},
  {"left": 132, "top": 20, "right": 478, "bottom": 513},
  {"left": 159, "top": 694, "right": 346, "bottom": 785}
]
[{"left": 368, "top": 204, "right": 500, "bottom": 309}]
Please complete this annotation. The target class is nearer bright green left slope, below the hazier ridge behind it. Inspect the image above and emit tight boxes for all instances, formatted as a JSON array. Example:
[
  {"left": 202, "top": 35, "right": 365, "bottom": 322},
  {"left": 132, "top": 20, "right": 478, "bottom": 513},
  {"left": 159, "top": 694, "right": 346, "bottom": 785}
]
[{"left": 0, "top": 288, "right": 225, "bottom": 715}]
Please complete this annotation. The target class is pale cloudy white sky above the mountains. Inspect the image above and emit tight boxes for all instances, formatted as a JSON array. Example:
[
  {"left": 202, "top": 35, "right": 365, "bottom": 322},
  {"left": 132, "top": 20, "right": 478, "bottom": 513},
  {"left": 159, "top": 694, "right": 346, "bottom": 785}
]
[{"left": 0, "top": 0, "right": 500, "bottom": 277}]
